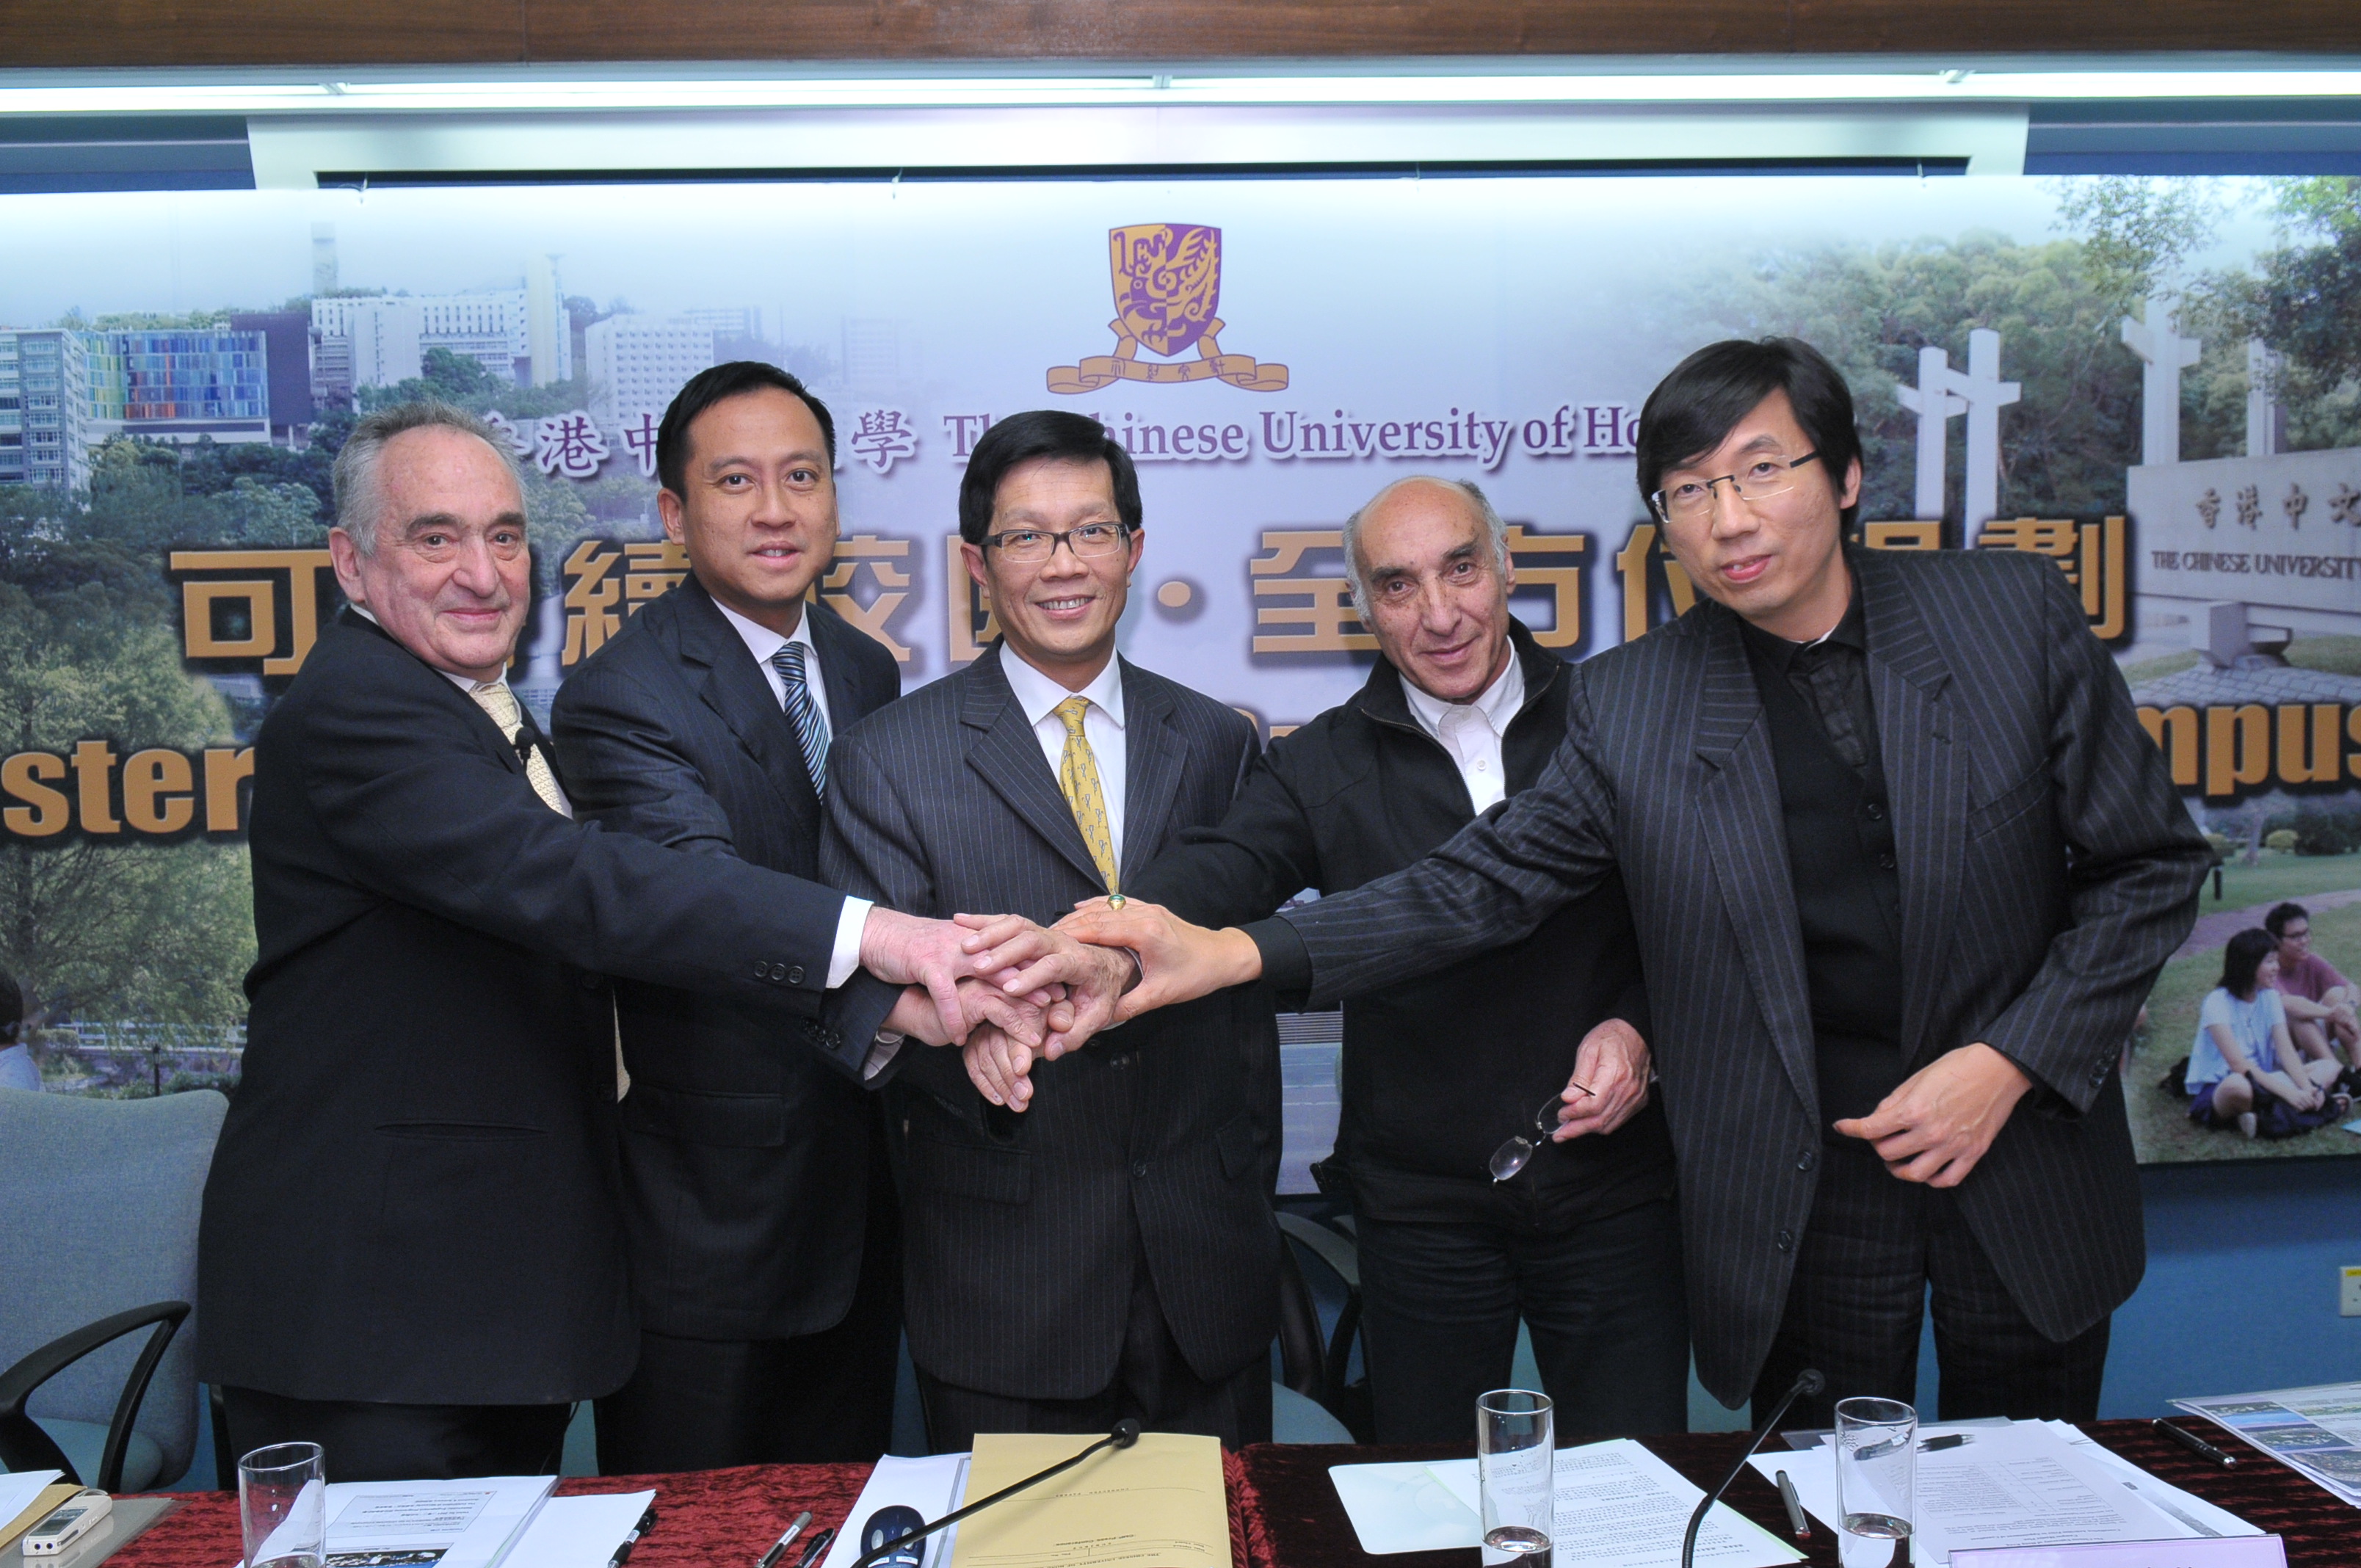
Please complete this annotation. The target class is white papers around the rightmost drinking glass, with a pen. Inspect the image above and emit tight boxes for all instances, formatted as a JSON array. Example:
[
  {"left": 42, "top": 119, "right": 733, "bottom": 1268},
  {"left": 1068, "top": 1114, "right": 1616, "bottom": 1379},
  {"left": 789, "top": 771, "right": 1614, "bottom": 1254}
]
[{"left": 1747, "top": 1422, "right": 2203, "bottom": 1568}]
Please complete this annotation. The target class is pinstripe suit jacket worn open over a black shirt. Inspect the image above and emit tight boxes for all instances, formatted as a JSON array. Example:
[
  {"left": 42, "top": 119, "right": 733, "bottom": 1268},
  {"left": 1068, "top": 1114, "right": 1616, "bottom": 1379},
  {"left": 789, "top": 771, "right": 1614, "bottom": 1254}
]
[{"left": 1266, "top": 551, "right": 2208, "bottom": 1405}]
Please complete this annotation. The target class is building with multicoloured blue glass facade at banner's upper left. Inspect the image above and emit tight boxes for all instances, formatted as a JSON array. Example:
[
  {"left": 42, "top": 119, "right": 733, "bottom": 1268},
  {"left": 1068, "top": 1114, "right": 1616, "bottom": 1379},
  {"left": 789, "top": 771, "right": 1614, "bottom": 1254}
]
[{"left": 80, "top": 328, "right": 272, "bottom": 446}]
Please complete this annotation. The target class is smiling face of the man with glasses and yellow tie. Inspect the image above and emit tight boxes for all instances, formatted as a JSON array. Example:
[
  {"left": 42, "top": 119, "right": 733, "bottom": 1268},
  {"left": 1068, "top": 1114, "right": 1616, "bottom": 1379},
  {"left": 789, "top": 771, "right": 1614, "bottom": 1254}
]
[{"left": 959, "top": 458, "right": 1145, "bottom": 692}]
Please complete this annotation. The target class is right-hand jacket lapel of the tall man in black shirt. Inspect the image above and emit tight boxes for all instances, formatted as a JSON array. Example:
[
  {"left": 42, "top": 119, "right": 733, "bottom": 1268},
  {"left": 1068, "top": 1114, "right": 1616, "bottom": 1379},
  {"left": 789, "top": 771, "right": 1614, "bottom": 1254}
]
[{"left": 1846, "top": 551, "right": 1969, "bottom": 1065}]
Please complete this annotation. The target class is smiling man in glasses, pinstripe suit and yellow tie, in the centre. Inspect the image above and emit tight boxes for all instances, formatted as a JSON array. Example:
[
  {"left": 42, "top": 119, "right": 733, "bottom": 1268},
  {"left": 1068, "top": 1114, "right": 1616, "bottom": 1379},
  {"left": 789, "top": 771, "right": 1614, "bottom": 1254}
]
[{"left": 822, "top": 411, "right": 1280, "bottom": 1450}]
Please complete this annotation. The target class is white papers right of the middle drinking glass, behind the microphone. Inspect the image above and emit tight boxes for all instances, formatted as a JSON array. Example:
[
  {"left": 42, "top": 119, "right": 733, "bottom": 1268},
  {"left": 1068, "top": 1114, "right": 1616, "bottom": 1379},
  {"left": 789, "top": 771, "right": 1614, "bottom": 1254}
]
[{"left": 1429, "top": 1438, "right": 1804, "bottom": 1568}]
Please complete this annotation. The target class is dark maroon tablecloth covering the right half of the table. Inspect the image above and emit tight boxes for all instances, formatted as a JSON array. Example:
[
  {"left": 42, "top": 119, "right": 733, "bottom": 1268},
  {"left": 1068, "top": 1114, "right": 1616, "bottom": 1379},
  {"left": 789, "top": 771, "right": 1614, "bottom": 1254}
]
[{"left": 1235, "top": 1422, "right": 2361, "bottom": 1568}]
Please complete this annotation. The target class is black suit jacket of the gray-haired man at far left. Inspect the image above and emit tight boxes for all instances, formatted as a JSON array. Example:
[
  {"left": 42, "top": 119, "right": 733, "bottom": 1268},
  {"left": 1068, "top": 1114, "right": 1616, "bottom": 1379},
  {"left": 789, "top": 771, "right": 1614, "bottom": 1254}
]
[{"left": 198, "top": 611, "right": 868, "bottom": 1405}]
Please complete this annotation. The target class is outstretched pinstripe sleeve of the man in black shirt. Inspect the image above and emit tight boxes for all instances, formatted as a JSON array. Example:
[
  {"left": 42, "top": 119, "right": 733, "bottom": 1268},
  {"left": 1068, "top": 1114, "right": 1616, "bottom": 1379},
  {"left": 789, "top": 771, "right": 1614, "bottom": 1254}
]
[{"left": 1251, "top": 666, "right": 1615, "bottom": 1009}]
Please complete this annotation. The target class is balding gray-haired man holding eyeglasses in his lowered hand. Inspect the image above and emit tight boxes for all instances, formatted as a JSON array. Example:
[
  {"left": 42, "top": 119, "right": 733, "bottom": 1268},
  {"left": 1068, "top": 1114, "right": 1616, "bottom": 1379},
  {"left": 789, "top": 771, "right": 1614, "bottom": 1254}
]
[{"left": 1124, "top": 477, "right": 1688, "bottom": 1443}]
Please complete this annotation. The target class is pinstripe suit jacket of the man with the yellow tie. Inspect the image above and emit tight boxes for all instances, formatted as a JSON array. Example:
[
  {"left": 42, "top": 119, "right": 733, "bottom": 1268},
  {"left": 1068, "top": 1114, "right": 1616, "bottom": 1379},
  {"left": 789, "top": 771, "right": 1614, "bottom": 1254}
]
[{"left": 822, "top": 647, "right": 1280, "bottom": 1398}]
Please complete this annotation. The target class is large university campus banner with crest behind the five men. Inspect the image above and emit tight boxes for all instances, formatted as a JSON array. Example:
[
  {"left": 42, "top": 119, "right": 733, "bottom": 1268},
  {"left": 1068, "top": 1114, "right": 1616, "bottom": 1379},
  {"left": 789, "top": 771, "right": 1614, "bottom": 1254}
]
[{"left": 0, "top": 177, "right": 2361, "bottom": 1161}]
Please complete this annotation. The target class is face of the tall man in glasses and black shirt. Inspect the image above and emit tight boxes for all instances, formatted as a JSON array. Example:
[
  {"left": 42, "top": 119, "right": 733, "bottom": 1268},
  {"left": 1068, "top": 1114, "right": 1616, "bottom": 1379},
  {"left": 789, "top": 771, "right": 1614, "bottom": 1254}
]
[{"left": 1658, "top": 392, "right": 1860, "bottom": 642}]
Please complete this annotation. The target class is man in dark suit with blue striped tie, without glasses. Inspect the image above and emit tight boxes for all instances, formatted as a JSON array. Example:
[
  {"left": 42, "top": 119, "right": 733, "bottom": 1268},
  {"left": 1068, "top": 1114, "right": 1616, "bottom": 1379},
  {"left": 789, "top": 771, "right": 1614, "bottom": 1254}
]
[{"left": 550, "top": 361, "right": 902, "bottom": 1473}]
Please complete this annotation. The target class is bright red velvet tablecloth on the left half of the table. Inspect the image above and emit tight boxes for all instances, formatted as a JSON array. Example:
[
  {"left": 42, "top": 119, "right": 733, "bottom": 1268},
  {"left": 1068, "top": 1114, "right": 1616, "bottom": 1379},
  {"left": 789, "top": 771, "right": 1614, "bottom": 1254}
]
[{"left": 106, "top": 1455, "right": 1256, "bottom": 1568}]
